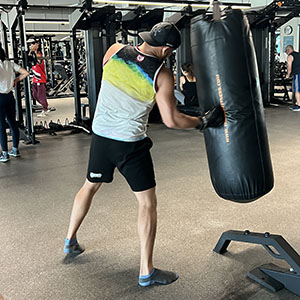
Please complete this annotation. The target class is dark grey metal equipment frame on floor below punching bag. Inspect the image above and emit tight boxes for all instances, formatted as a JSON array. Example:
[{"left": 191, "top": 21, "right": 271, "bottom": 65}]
[{"left": 214, "top": 230, "right": 300, "bottom": 296}]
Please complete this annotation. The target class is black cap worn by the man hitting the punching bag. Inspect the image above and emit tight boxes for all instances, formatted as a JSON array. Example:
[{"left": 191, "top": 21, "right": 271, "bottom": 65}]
[{"left": 139, "top": 22, "right": 181, "bottom": 49}]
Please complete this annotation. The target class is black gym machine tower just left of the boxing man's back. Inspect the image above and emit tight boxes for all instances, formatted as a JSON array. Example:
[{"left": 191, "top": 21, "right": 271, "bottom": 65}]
[{"left": 70, "top": 0, "right": 118, "bottom": 123}]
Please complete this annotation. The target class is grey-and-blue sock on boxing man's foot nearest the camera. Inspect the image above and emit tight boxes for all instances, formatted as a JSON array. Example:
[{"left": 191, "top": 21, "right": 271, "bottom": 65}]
[{"left": 139, "top": 268, "right": 179, "bottom": 287}]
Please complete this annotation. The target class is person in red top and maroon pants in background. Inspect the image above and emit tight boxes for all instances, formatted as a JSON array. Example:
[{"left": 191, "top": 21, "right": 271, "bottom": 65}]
[{"left": 30, "top": 41, "right": 55, "bottom": 117}]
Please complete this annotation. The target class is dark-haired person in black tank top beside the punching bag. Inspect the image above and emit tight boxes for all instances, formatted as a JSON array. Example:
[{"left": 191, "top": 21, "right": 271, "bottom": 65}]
[{"left": 179, "top": 63, "right": 199, "bottom": 107}]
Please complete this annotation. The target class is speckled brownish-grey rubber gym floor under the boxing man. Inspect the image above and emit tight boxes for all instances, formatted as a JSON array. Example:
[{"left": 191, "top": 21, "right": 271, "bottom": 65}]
[{"left": 0, "top": 101, "right": 300, "bottom": 300}]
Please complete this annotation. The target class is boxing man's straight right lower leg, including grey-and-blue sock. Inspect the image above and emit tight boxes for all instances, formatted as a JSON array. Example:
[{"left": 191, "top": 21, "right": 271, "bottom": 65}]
[{"left": 135, "top": 187, "right": 178, "bottom": 286}]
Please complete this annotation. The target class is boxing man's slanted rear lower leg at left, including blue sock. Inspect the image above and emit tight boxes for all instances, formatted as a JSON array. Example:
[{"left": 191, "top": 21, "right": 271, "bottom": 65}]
[{"left": 64, "top": 180, "right": 101, "bottom": 254}]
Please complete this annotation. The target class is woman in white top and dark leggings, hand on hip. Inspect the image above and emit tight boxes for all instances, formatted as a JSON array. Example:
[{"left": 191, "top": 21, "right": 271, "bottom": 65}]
[{"left": 0, "top": 45, "right": 29, "bottom": 163}]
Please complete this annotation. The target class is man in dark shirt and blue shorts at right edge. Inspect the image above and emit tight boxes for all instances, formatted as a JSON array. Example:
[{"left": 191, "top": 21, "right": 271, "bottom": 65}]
[{"left": 285, "top": 45, "right": 300, "bottom": 111}]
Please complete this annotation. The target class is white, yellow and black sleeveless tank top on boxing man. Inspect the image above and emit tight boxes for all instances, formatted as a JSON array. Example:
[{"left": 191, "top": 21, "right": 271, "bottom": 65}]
[{"left": 92, "top": 46, "right": 162, "bottom": 142}]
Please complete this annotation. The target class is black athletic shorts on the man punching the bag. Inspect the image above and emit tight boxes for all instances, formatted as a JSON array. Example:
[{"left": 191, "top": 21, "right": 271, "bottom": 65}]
[{"left": 87, "top": 134, "right": 156, "bottom": 192}]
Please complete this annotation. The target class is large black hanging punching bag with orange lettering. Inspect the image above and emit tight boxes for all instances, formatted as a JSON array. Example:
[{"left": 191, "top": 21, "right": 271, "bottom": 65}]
[{"left": 191, "top": 9, "right": 273, "bottom": 202}]
